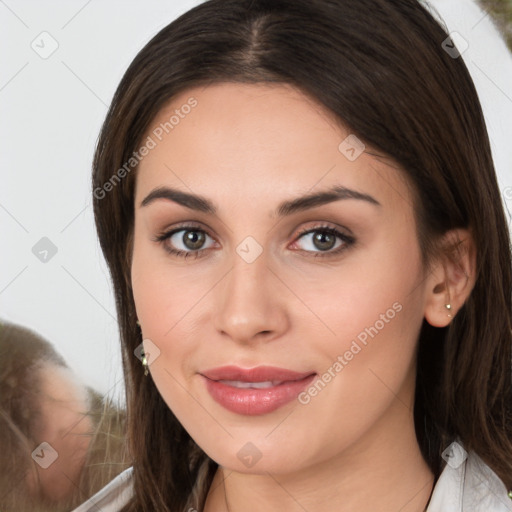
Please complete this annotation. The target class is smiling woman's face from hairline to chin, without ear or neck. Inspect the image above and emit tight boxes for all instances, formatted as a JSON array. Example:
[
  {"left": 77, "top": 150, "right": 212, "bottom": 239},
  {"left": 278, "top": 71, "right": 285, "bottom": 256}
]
[{"left": 132, "top": 83, "right": 427, "bottom": 473}]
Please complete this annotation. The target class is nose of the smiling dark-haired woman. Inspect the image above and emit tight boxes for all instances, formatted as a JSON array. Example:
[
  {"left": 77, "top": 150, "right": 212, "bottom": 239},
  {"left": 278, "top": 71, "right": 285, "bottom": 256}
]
[{"left": 214, "top": 246, "right": 289, "bottom": 344}]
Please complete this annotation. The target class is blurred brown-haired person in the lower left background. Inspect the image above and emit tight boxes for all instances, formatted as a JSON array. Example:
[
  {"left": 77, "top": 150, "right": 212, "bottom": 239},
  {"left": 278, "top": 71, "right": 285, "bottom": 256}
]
[{"left": 0, "top": 321, "right": 130, "bottom": 512}]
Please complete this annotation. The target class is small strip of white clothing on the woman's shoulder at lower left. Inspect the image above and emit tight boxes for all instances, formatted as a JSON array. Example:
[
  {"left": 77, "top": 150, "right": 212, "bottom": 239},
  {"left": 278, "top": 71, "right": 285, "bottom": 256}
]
[{"left": 72, "top": 467, "right": 133, "bottom": 512}]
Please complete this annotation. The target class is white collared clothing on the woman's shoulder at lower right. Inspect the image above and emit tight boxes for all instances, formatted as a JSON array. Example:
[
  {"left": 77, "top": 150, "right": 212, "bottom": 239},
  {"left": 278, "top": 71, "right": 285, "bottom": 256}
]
[{"left": 427, "top": 442, "right": 512, "bottom": 512}]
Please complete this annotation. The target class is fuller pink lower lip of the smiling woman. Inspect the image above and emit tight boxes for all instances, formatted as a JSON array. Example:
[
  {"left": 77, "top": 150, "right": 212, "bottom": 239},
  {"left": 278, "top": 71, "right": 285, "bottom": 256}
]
[{"left": 203, "top": 374, "right": 316, "bottom": 416}]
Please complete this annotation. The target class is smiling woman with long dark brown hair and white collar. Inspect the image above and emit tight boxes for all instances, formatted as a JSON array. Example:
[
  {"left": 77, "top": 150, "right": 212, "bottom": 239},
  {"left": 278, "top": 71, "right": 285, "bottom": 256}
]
[{"left": 77, "top": 0, "right": 512, "bottom": 512}]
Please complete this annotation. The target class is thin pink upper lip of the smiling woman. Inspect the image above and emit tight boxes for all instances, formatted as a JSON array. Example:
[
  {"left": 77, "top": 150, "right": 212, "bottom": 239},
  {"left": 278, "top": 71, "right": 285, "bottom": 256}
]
[{"left": 200, "top": 366, "right": 315, "bottom": 382}]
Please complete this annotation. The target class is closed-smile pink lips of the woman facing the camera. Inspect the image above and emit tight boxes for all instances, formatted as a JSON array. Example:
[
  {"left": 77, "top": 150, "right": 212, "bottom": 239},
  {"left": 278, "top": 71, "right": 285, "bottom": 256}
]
[{"left": 200, "top": 366, "right": 316, "bottom": 416}]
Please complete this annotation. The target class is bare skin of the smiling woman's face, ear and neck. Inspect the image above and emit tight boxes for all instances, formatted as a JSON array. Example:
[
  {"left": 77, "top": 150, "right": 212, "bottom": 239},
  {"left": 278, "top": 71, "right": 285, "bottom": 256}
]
[{"left": 132, "top": 83, "right": 473, "bottom": 512}]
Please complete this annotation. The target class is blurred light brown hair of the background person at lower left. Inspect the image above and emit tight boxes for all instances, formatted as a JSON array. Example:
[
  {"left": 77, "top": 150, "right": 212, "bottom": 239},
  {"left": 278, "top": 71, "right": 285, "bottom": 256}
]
[{"left": 0, "top": 322, "right": 131, "bottom": 512}]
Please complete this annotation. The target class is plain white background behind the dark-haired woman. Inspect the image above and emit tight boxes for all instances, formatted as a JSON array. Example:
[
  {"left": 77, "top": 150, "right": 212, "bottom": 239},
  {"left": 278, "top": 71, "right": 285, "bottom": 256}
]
[{"left": 0, "top": 0, "right": 512, "bottom": 406}]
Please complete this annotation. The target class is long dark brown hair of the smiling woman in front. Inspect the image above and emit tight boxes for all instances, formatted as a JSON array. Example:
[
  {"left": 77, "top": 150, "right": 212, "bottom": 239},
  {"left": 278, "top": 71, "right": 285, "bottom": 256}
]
[{"left": 92, "top": 0, "right": 512, "bottom": 512}]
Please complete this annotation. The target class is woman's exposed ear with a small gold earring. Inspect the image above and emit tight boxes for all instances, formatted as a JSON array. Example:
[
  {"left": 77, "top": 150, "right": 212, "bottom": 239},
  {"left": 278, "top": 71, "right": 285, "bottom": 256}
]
[{"left": 425, "top": 229, "right": 476, "bottom": 327}]
